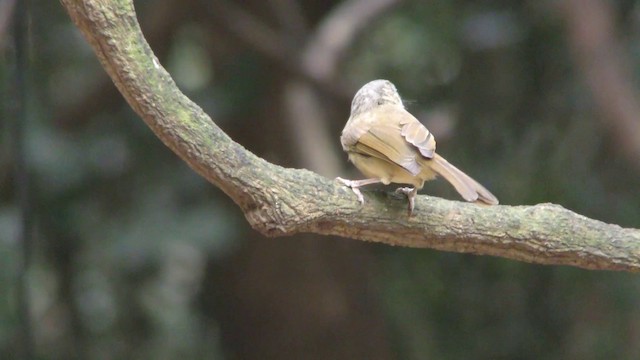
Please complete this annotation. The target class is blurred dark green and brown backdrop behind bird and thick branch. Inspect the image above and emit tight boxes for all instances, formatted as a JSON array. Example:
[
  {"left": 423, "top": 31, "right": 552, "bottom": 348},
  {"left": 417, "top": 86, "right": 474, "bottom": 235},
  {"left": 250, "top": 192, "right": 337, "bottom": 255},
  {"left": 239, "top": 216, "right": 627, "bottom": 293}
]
[{"left": 0, "top": 0, "right": 640, "bottom": 359}]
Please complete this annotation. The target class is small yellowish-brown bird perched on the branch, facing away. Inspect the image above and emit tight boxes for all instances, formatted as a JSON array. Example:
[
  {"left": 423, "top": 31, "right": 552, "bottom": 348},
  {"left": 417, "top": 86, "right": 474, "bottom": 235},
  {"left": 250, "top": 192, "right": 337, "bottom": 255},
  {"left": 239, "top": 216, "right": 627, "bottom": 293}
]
[{"left": 337, "top": 79, "right": 498, "bottom": 215}]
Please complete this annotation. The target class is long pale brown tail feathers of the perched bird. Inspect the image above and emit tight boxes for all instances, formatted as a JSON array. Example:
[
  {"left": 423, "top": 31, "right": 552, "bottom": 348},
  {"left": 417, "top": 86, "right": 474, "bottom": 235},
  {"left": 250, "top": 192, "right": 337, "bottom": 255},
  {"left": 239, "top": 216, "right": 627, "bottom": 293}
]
[{"left": 430, "top": 154, "right": 498, "bottom": 205}]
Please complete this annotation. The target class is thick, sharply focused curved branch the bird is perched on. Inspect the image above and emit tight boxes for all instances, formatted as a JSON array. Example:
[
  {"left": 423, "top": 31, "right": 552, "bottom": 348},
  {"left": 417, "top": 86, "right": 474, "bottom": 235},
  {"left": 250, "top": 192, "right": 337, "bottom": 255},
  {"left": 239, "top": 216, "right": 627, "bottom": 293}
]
[{"left": 61, "top": 0, "right": 640, "bottom": 271}]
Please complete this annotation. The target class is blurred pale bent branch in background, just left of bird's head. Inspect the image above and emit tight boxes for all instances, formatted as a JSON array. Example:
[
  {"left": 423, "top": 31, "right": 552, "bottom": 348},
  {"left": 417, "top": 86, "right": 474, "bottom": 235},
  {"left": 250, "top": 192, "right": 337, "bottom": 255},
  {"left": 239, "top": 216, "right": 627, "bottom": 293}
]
[{"left": 278, "top": 0, "right": 399, "bottom": 177}]
